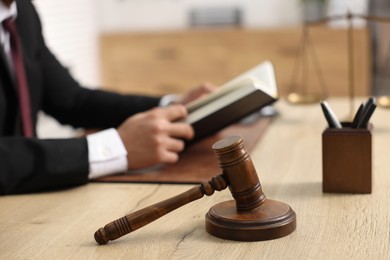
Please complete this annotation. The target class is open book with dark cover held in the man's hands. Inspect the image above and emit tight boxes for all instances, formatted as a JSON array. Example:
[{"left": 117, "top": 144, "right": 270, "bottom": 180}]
[{"left": 186, "top": 61, "right": 278, "bottom": 143}]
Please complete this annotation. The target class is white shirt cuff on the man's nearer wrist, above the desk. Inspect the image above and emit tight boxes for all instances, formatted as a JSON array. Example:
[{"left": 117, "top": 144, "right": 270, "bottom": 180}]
[{"left": 87, "top": 128, "right": 128, "bottom": 179}]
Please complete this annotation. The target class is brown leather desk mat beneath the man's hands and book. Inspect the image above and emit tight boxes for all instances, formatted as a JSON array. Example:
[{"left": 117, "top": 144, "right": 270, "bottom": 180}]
[{"left": 95, "top": 117, "right": 272, "bottom": 184}]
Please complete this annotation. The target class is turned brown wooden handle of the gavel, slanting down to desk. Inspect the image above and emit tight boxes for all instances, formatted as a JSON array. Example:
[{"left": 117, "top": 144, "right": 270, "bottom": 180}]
[{"left": 95, "top": 174, "right": 227, "bottom": 244}]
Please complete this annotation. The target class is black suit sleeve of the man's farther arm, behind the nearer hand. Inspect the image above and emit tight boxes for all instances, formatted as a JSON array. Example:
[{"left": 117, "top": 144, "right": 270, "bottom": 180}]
[{"left": 42, "top": 48, "right": 160, "bottom": 128}]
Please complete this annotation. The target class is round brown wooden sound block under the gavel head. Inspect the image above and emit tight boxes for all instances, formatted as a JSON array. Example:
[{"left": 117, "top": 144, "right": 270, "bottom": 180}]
[{"left": 206, "top": 199, "right": 296, "bottom": 241}]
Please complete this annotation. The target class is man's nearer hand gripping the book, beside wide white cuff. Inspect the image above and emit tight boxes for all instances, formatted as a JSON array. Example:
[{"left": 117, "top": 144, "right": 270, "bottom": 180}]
[{"left": 118, "top": 105, "right": 194, "bottom": 169}]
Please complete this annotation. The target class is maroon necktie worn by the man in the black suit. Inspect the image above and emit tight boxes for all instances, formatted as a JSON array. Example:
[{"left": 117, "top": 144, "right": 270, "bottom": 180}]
[{"left": 3, "top": 18, "right": 34, "bottom": 137}]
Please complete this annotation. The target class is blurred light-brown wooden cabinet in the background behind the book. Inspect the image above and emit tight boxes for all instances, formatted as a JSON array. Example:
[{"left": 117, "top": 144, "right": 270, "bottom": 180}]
[{"left": 100, "top": 27, "right": 371, "bottom": 96}]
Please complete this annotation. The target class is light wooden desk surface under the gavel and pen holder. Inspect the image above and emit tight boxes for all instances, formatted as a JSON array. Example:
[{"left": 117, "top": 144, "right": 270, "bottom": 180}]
[{"left": 0, "top": 99, "right": 390, "bottom": 259}]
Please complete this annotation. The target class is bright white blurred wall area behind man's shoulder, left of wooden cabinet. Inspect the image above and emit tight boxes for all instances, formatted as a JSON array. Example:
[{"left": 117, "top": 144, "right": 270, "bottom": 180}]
[{"left": 33, "top": 0, "right": 99, "bottom": 87}]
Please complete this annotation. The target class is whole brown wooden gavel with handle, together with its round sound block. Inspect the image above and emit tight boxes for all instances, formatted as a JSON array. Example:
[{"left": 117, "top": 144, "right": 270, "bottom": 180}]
[{"left": 95, "top": 136, "right": 296, "bottom": 244}]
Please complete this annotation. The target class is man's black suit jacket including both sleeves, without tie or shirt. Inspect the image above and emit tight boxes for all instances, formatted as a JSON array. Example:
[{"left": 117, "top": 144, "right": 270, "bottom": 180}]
[{"left": 0, "top": 0, "right": 159, "bottom": 194}]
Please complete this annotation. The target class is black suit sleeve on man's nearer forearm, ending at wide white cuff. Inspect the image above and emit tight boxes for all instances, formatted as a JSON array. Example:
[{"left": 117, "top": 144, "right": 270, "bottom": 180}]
[{"left": 0, "top": 137, "right": 89, "bottom": 195}]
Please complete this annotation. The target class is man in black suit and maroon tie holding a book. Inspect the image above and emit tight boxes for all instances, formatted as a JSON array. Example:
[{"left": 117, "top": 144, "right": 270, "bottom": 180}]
[{"left": 0, "top": 0, "right": 212, "bottom": 194}]
